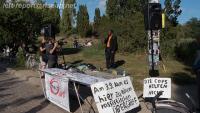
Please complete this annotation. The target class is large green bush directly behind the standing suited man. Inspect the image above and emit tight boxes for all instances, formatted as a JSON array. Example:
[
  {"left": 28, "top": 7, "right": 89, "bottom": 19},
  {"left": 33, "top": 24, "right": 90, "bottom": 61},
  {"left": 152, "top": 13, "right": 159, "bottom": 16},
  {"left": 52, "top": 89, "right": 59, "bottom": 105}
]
[{"left": 98, "top": 12, "right": 147, "bottom": 53}]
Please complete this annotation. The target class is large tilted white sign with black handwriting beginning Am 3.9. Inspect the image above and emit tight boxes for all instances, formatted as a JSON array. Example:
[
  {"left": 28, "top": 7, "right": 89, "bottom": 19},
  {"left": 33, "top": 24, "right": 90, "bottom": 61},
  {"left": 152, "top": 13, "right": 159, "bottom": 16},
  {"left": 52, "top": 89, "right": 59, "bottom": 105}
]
[{"left": 91, "top": 77, "right": 139, "bottom": 113}]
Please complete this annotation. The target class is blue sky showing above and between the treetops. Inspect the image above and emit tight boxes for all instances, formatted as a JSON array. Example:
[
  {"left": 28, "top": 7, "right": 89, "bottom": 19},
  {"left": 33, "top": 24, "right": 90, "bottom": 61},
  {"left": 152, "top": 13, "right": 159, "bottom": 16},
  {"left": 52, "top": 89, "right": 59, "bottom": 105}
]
[{"left": 46, "top": 0, "right": 200, "bottom": 24}]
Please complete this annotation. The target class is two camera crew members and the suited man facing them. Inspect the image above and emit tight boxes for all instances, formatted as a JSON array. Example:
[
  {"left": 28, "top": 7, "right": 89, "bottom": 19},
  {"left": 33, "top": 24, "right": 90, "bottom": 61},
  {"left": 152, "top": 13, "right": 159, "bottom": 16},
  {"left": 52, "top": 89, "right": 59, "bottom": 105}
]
[{"left": 40, "top": 30, "right": 118, "bottom": 69}]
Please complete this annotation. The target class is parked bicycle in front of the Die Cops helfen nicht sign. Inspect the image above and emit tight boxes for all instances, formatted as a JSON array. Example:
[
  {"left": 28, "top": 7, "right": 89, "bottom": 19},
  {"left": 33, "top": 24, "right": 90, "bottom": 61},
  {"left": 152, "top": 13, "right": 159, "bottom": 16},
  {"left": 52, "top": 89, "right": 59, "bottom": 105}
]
[{"left": 138, "top": 91, "right": 197, "bottom": 113}]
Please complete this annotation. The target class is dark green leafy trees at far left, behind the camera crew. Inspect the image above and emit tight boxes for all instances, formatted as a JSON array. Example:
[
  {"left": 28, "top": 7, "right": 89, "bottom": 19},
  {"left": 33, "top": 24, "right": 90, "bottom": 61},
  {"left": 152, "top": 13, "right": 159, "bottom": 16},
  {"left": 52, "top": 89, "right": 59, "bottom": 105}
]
[{"left": 0, "top": 0, "right": 60, "bottom": 48}]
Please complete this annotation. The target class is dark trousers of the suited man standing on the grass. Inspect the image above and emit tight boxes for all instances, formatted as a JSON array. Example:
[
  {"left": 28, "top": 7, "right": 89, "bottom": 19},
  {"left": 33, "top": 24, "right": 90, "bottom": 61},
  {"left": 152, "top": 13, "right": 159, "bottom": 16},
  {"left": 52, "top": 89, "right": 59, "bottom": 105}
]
[{"left": 105, "top": 48, "right": 115, "bottom": 69}]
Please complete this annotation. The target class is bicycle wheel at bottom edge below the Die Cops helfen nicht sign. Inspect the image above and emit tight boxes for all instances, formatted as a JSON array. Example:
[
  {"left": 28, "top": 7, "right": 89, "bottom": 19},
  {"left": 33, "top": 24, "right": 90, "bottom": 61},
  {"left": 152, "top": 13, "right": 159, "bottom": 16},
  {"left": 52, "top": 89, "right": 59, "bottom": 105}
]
[{"left": 156, "top": 100, "right": 191, "bottom": 113}]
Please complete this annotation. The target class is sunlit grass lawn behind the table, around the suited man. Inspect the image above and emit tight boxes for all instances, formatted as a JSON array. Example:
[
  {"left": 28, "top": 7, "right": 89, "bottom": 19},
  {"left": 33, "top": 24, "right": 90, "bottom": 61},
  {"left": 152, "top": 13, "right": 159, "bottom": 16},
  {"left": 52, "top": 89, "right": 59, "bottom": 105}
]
[{"left": 57, "top": 39, "right": 195, "bottom": 90}]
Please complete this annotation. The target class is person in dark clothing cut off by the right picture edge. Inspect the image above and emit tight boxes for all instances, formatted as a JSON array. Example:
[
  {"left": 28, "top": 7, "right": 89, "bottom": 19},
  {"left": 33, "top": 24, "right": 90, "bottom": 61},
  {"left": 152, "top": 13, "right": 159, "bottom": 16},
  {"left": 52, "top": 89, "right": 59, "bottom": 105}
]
[{"left": 193, "top": 38, "right": 200, "bottom": 110}]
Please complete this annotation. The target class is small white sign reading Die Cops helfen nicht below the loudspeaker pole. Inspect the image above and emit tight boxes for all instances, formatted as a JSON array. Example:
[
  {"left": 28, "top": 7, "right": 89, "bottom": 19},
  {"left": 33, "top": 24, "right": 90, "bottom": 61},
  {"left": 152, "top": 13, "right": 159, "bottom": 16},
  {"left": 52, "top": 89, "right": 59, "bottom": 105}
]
[{"left": 143, "top": 78, "right": 171, "bottom": 98}]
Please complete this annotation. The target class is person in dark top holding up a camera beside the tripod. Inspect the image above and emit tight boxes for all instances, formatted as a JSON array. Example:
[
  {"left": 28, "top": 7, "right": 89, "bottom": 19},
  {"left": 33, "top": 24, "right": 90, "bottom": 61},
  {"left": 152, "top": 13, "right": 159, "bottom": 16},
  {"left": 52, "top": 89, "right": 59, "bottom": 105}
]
[{"left": 45, "top": 37, "right": 58, "bottom": 68}]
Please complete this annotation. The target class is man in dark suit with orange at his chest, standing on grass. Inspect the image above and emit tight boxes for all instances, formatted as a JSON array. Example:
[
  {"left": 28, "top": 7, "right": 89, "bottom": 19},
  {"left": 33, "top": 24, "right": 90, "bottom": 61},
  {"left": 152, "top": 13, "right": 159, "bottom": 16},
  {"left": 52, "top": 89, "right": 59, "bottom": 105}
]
[{"left": 104, "top": 30, "right": 118, "bottom": 69}]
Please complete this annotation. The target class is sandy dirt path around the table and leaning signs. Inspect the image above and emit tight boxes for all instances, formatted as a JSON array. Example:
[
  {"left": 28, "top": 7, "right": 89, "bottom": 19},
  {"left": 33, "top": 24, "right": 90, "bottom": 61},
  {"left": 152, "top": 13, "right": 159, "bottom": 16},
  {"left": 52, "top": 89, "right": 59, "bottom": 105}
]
[{"left": 0, "top": 62, "right": 198, "bottom": 113}]
